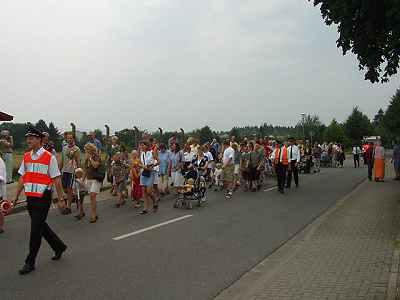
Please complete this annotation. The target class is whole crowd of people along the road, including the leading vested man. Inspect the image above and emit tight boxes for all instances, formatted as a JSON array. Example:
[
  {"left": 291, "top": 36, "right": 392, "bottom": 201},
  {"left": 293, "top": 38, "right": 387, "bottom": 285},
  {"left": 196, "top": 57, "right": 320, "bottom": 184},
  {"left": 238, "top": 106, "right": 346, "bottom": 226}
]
[{"left": 0, "top": 123, "right": 400, "bottom": 274}]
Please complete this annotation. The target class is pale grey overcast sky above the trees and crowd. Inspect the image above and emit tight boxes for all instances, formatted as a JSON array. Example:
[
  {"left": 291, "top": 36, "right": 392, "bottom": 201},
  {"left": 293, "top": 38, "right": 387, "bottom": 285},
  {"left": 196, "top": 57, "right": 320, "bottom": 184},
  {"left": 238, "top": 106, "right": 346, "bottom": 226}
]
[{"left": 0, "top": 0, "right": 400, "bottom": 130}]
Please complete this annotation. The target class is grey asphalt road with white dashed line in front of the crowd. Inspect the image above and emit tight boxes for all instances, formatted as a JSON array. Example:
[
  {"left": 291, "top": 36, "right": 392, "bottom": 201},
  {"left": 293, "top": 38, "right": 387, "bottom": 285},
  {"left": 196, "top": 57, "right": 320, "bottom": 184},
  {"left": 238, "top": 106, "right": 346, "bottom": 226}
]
[{"left": 0, "top": 163, "right": 366, "bottom": 300}]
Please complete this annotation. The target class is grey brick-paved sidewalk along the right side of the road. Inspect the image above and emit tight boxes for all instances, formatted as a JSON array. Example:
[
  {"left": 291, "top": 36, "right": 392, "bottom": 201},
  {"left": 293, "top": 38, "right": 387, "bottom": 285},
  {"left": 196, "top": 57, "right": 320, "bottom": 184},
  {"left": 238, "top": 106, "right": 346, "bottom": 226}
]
[{"left": 215, "top": 166, "right": 400, "bottom": 300}]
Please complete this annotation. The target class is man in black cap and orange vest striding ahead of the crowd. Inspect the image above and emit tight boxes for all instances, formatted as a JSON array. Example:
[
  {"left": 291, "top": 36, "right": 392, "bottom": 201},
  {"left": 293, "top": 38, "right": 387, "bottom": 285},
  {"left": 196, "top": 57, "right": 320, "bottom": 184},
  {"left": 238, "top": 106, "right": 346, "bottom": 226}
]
[{"left": 13, "top": 127, "right": 67, "bottom": 275}]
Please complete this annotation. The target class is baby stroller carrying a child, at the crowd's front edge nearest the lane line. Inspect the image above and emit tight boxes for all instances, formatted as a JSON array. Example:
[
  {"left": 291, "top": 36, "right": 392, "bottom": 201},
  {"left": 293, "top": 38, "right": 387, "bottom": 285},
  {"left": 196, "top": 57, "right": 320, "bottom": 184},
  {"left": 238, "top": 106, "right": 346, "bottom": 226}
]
[{"left": 174, "top": 166, "right": 207, "bottom": 209}]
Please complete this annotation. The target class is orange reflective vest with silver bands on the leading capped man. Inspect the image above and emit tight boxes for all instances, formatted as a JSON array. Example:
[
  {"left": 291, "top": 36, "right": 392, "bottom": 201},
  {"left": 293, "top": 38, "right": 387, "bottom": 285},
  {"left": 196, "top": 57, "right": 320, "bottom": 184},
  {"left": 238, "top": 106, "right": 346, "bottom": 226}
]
[{"left": 22, "top": 151, "right": 53, "bottom": 198}]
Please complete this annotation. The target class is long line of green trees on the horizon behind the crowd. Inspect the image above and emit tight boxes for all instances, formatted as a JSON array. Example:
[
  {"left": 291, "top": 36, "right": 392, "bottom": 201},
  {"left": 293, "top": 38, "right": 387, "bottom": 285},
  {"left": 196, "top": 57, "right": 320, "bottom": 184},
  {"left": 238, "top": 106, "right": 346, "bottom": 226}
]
[{"left": 0, "top": 89, "right": 400, "bottom": 151}]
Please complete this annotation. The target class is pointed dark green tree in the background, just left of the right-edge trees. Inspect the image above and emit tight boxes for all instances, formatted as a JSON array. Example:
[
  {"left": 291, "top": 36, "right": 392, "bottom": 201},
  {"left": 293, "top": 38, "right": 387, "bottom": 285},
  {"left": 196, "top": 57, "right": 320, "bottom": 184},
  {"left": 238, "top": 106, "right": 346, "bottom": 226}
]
[{"left": 344, "top": 106, "right": 373, "bottom": 144}]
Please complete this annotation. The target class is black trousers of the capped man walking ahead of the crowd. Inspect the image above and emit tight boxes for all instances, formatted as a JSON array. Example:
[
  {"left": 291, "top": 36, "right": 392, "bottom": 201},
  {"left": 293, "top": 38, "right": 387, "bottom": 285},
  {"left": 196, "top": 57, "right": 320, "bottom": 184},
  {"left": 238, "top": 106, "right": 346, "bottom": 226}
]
[{"left": 25, "top": 192, "right": 66, "bottom": 266}]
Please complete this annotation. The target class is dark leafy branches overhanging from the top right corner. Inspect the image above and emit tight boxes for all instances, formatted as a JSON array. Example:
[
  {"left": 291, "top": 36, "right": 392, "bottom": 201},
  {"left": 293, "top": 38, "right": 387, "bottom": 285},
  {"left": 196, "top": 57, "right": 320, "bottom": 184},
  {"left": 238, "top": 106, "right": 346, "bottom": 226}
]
[{"left": 308, "top": 0, "right": 400, "bottom": 83}]
